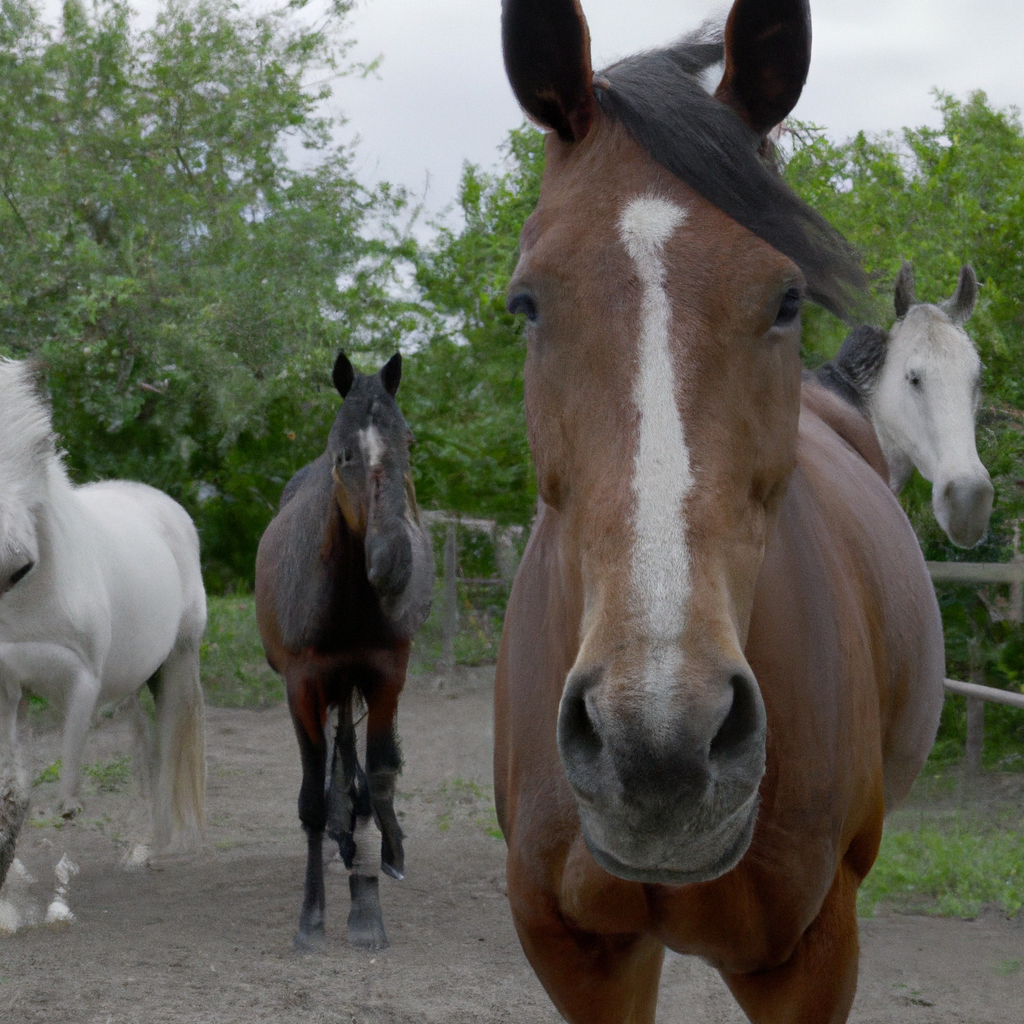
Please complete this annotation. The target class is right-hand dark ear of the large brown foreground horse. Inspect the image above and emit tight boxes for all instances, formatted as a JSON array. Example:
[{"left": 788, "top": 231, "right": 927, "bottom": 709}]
[{"left": 715, "top": 0, "right": 811, "bottom": 138}]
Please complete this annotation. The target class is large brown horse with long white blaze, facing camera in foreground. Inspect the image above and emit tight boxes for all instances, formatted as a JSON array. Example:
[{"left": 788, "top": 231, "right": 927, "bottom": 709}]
[{"left": 495, "top": 0, "right": 944, "bottom": 1024}]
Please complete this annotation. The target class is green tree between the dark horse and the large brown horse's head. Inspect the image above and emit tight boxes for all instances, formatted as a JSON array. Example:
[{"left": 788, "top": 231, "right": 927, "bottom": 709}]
[{"left": 402, "top": 127, "right": 544, "bottom": 523}]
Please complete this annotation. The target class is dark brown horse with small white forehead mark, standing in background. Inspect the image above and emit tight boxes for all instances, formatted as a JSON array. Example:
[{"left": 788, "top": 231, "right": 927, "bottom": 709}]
[{"left": 256, "top": 353, "right": 434, "bottom": 949}]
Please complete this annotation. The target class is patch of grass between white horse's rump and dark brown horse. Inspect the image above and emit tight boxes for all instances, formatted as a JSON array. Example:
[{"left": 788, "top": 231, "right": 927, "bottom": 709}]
[{"left": 200, "top": 596, "right": 285, "bottom": 708}]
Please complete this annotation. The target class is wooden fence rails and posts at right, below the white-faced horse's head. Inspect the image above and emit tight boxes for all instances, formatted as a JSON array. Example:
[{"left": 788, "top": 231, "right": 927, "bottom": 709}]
[{"left": 927, "top": 565, "right": 1024, "bottom": 774}]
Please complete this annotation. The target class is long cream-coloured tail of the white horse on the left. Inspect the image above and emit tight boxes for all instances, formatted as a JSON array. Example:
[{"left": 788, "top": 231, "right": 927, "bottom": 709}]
[{"left": 153, "top": 637, "right": 206, "bottom": 849}]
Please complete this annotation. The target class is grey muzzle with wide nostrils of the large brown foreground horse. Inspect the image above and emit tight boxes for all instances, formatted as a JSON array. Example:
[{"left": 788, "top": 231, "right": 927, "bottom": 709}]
[{"left": 558, "top": 665, "right": 766, "bottom": 885}]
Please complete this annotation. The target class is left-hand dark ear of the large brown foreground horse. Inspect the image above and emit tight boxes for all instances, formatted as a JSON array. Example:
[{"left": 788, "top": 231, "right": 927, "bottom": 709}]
[{"left": 502, "top": 0, "right": 595, "bottom": 142}]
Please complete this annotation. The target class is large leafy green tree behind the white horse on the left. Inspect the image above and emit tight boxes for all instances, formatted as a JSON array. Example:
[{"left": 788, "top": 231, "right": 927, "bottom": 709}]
[{"left": 0, "top": 0, "right": 412, "bottom": 589}]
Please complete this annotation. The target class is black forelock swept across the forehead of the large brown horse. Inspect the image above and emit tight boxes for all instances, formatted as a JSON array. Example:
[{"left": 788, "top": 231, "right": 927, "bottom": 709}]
[{"left": 594, "top": 31, "right": 867, "bottom": 322}]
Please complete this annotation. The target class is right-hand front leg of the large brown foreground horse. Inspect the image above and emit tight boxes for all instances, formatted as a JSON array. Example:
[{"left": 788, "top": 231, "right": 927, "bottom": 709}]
[{"left": 722, "top": 861, "right": 860, "bottom": 1024}]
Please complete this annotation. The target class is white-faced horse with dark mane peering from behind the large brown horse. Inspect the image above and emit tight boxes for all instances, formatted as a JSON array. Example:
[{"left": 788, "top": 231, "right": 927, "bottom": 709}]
[{"left": 816, "top": 263, "right": 994, "bottom": 548}]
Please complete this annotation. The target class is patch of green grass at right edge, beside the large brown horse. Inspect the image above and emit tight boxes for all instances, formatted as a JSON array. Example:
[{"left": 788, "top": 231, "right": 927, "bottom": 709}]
[{"left": 857, "top": 816, "right": 1024, "bottom": 918}]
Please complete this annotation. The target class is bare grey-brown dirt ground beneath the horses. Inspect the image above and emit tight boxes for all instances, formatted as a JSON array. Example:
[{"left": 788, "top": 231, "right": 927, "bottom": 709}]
[{"left": 0, "top": 670, "right": 1024, "bottom": 1024}]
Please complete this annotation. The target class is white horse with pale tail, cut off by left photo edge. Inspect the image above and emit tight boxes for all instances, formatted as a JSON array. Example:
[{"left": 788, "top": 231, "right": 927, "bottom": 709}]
[{"left": 0, "top": 359, "right": 206, "bottom": 885}]
